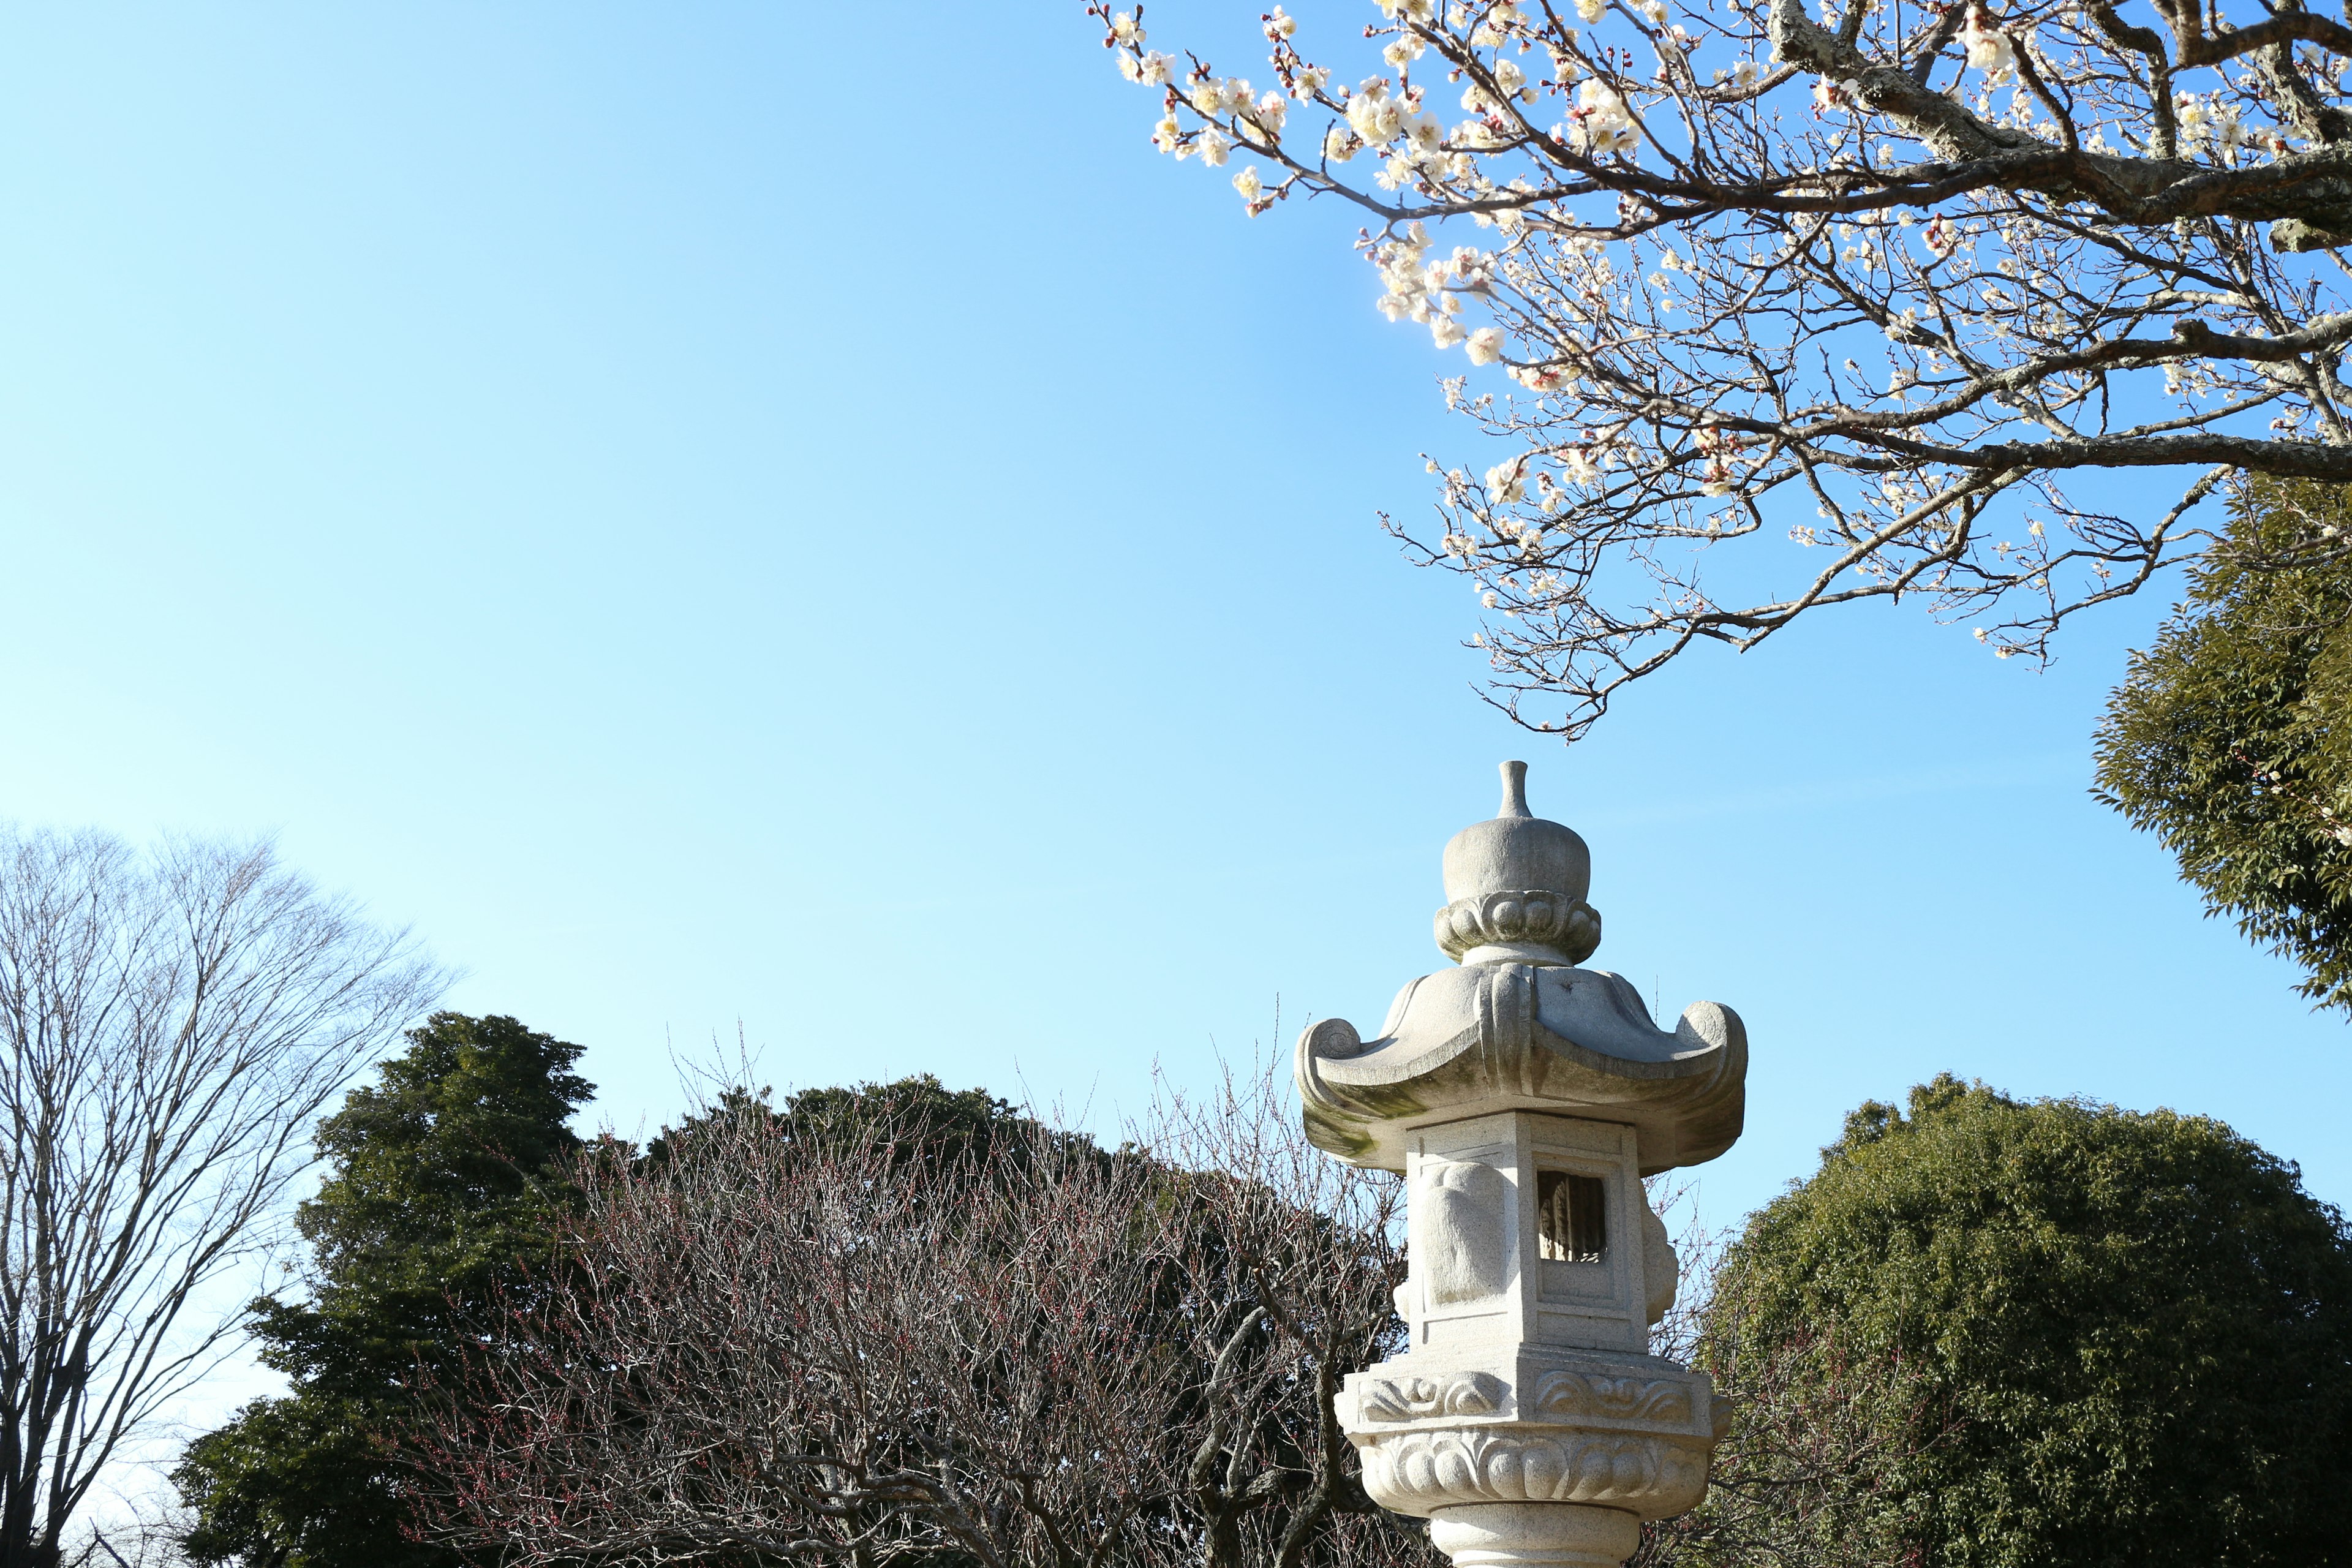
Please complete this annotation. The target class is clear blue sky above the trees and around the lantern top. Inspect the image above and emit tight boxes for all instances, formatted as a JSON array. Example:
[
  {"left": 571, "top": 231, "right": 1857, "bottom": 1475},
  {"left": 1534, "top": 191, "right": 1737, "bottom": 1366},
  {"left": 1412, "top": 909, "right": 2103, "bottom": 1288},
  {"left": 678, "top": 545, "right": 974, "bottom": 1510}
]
[{"left": 0, "top": 0, "right": 2352, "bottom": 1288}]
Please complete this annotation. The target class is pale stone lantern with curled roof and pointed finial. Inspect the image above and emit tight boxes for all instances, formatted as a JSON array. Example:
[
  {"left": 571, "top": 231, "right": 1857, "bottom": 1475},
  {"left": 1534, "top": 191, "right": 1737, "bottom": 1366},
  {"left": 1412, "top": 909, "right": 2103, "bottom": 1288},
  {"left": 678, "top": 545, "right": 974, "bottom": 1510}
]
[{"left": 1298, "top": 762, "right": 1747, "bottom": 1568}]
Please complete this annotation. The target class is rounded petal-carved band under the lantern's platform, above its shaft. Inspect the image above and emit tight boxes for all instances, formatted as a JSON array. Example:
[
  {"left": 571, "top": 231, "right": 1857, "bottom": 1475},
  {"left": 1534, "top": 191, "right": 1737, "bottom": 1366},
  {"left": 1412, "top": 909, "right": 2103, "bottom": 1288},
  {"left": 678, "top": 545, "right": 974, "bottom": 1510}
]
[{"left": 1362, "top": 1427, "right": 1708, "bottom": 1518}]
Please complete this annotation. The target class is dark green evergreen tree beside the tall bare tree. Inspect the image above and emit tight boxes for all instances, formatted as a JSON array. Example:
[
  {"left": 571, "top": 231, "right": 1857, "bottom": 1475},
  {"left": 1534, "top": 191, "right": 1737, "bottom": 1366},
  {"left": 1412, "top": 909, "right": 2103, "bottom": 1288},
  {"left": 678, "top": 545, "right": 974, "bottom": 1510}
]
[{"left": 172, "top": 1013, "right": 593, "bottom": 1568}]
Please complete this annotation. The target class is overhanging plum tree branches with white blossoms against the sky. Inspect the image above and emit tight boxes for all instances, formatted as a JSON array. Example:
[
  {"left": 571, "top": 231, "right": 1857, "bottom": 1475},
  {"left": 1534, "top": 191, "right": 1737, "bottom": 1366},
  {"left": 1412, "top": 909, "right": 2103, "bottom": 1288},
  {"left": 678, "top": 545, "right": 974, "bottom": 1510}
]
[{"left": 1089, "top": 0, "right": 2352, "bottom": 733}]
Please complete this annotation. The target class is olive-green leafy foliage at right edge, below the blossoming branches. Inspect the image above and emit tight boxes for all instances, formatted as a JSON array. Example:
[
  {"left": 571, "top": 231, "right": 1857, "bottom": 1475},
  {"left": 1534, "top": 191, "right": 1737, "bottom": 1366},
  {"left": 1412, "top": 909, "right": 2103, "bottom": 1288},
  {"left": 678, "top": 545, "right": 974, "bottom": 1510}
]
[{"left": 2095, "top": 480, "right": 2352, "bottom": 1011}]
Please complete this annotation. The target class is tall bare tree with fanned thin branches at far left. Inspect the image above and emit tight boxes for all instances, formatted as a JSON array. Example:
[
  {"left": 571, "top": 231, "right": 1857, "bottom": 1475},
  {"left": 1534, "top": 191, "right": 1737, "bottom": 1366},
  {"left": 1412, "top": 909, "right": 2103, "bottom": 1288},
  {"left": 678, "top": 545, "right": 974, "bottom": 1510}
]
[{"left": 0, "top": 830, "right": 437, "bottom": 1568}]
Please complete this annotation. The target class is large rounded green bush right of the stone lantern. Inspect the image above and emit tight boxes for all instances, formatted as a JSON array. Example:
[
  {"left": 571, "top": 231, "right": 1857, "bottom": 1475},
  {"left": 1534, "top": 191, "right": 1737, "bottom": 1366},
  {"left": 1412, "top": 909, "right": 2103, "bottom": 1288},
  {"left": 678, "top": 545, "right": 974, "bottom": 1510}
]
[{"left": 1682, "top": 1077, "right": 2352, "bottom": 1568}]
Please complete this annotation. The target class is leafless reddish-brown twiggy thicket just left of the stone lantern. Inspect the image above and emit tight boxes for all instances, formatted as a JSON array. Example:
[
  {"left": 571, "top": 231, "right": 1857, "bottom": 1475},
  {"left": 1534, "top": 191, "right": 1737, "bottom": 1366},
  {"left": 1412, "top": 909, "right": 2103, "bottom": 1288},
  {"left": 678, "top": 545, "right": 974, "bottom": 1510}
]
[{"left": 428, "top": 1067, "right": 1428, "bottom": 1568}]
